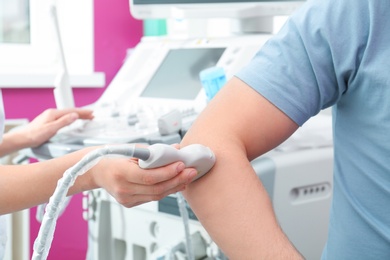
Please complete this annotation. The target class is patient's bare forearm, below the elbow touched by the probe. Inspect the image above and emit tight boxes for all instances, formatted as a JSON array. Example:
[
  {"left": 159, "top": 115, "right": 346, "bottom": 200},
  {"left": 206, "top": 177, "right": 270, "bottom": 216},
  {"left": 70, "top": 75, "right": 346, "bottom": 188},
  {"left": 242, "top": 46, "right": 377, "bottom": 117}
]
[{"left": 181, "top": 143, "right": 300, "bottom": 259}]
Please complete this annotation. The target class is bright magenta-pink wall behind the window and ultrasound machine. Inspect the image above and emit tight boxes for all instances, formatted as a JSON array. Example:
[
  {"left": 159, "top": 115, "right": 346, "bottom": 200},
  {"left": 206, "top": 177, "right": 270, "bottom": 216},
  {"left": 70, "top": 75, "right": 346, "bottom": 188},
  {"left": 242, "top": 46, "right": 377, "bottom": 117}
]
[{"left": 2, "top": 0, "right": 142, "bottom": 260}]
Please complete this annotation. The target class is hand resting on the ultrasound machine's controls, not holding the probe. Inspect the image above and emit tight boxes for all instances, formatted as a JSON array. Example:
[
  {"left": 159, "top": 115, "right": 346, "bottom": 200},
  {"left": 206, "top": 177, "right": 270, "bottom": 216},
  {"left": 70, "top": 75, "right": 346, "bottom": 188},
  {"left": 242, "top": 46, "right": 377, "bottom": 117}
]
[{"left": 21, "top": 108, "right": 93, "bottom": 147}]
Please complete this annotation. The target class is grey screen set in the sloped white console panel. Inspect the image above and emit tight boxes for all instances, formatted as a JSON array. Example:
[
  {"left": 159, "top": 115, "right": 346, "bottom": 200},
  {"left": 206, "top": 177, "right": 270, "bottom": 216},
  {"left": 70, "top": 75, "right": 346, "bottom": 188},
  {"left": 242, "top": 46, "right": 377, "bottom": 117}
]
[{"left": 140, "top": 48, "right": 225, "bottom": 100}]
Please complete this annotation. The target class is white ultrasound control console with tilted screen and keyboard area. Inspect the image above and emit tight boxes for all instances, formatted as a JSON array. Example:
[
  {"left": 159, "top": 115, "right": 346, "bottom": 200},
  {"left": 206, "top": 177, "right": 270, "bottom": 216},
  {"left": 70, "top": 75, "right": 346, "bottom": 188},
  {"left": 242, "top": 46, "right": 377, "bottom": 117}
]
[{"left": 32, "top": 34, "right": 269, "bottom": 159}]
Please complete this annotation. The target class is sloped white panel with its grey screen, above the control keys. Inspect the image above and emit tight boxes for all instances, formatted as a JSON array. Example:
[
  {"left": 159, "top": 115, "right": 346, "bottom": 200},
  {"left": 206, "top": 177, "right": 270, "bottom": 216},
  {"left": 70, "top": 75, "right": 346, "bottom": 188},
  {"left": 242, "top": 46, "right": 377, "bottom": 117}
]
[{"left": 97, "top": 34, "right": 270, "bottom": 113}]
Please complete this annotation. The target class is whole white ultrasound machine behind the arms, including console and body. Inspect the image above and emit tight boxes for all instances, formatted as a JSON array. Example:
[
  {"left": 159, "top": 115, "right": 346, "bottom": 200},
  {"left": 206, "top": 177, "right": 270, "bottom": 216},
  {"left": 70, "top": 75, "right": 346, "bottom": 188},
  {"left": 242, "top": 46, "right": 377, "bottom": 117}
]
[{"left": 25, "top": 0, "right": 333, "bottom": 260}]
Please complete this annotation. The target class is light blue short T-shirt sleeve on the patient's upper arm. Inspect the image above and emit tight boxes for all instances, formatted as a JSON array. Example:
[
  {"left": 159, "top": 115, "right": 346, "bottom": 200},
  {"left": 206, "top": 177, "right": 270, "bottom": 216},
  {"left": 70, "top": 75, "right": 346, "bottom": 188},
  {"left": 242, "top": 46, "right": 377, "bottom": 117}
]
[{"left": 236, "top": 0, "right": 366, "bottom": 125}]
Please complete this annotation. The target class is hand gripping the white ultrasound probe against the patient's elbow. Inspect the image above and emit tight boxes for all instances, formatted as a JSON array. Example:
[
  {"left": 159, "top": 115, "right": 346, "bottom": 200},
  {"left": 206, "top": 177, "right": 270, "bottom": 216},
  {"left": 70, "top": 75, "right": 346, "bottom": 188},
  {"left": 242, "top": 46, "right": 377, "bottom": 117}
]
[{"left": 89, "top": 158, "right": 196, "bottom": 208}]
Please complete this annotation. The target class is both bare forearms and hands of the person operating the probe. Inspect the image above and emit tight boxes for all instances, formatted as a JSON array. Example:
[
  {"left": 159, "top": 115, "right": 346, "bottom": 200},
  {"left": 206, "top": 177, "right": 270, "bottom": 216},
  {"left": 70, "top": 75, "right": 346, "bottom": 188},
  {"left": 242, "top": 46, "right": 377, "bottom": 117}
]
[{"left": 0, "top": 108, "right": 196, "bottom": 215}]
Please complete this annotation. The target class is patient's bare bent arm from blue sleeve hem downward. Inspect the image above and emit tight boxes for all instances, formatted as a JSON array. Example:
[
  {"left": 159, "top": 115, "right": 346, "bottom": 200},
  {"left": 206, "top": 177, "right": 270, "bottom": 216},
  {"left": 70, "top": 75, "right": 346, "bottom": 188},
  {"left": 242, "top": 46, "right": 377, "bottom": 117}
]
[{"left": 181, "top": 78, "right": 301, "bottom": 259}]
